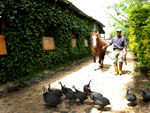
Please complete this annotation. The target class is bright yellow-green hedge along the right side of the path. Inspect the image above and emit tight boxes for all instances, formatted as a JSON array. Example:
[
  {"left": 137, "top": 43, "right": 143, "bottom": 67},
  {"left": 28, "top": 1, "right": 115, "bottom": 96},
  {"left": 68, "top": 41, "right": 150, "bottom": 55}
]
[{"left": 129, "top": 5, "right": 150, "bottom": 72}]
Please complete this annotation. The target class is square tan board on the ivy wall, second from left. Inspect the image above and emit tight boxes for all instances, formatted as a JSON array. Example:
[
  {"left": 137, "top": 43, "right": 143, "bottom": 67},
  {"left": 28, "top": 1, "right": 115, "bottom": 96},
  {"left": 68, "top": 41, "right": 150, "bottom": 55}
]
[{"left": 43, "top": 37, "right": 55, "bottom": 50}]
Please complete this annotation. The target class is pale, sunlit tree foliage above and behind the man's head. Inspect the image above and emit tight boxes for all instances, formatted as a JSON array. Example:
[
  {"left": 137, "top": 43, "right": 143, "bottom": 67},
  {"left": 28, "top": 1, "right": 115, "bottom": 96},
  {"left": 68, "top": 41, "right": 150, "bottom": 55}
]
[{"left": 108, "top": 0, "right": 129, "bottom": 40}]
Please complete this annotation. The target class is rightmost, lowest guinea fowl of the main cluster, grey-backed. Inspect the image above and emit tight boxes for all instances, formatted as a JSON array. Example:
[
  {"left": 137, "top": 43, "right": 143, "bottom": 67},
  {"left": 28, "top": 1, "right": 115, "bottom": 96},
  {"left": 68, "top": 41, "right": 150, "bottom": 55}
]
[{"left": 93, "top": 96, "right": 110, "bottom": 111}]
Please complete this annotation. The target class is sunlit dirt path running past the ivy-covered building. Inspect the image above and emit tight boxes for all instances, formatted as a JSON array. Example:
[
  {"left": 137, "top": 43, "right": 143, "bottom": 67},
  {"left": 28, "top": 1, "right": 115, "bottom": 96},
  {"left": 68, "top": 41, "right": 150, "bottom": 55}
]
[{"left": 0, "top": 48, "right": 150, "bottom": 113}]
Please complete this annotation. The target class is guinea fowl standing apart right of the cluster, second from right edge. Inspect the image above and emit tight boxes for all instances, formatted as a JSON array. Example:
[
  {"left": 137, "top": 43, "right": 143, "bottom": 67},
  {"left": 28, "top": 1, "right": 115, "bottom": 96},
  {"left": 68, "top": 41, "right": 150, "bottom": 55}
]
[{"left": 126, "top": 87, "right": 136, "bottom": 105}]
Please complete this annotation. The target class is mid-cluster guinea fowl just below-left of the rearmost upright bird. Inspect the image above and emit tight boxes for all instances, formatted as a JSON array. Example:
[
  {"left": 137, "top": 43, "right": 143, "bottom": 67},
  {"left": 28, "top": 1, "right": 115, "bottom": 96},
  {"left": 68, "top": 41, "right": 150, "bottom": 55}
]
[{"left": 72, "top": 86, "right": 87, "bottom": 103}]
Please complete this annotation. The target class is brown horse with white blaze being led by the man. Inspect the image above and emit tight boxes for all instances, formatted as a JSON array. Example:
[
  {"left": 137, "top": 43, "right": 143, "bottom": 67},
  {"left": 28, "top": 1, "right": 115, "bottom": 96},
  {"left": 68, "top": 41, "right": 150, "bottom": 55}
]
[{"left": 91, "top": 32, "right": 108, "bottom": 67}]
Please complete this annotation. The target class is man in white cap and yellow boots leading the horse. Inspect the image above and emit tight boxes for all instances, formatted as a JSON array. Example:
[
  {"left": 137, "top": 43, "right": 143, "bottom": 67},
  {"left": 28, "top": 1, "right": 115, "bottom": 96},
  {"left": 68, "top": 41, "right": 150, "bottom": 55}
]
[{"left": 105, "top": 29, "right": 127, "bottom": 75}]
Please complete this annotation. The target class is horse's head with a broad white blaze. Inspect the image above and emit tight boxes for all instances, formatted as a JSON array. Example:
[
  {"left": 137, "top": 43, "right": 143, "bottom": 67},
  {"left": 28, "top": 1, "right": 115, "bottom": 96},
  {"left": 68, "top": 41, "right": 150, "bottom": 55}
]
[{"left": 91, "top": 32, "right": 99, "bottom": 48}]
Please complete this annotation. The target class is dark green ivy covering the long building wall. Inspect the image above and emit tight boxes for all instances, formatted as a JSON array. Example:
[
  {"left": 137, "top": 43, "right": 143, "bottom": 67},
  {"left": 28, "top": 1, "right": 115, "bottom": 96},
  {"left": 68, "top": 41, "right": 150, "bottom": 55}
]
[{"left": 0, "top": 0, "right": 93, "bottom": 83}]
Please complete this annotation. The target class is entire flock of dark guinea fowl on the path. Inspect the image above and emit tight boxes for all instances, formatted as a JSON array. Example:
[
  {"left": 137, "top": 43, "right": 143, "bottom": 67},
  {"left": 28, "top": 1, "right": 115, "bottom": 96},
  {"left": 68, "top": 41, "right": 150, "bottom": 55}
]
[{"left": 42, "top": 80, "right": 150, "bottom": 111}]
